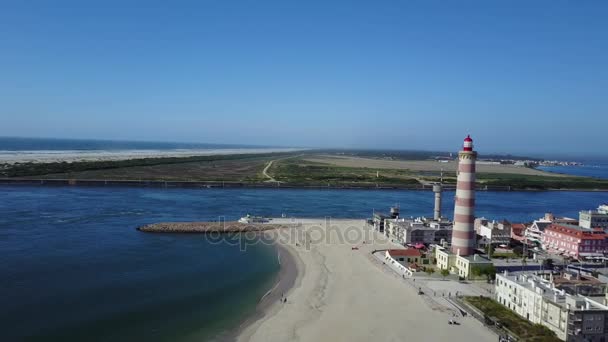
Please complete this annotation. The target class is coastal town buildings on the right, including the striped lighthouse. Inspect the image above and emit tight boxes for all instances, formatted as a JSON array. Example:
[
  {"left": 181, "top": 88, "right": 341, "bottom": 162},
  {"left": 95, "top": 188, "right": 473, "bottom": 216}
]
[{"left": 368, "top": 137, "right": 608, "bottom": 342}]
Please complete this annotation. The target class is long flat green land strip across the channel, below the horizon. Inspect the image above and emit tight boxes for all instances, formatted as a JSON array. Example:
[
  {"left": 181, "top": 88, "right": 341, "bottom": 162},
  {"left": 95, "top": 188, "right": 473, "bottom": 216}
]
[{"left": 0, "top": 151, "right": 608, "bottom": 191}]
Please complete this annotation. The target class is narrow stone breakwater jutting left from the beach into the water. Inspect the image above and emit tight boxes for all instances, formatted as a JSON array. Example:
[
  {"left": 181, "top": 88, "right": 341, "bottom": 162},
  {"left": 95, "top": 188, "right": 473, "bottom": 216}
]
[{"left": 137, "top": 221, "right": 290, "bottom": 234}]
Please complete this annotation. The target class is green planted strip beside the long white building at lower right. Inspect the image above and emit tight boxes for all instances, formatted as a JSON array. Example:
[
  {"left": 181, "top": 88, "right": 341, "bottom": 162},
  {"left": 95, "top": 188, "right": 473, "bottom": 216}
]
[{"left": 464, "top": 297, "right": 561, "bottom": 342}]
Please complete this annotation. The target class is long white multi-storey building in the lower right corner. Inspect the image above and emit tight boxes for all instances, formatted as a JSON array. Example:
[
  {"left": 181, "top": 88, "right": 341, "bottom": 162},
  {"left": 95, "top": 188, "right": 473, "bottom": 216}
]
[{"left": 495, "top": 272, "right": 608, "bottom": 342}]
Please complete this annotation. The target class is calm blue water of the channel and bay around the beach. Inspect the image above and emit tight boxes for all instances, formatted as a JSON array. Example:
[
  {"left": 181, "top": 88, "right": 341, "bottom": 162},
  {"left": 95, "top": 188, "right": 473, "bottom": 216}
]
[{"left": 0, "top": 186, "right": 608, "bottom": 341}]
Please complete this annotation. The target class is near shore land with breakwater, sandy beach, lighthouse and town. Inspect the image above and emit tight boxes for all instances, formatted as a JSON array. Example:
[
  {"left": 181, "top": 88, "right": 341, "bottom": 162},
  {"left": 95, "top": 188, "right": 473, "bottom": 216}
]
[{"left": 138, "top": 136, "right": 608, "bottom": 342}]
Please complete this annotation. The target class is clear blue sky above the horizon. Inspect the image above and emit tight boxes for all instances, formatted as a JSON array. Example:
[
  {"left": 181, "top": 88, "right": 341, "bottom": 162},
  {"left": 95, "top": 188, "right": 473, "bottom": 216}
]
[{"left": 0, "top": 0, "right": 608, "bottom": 154}]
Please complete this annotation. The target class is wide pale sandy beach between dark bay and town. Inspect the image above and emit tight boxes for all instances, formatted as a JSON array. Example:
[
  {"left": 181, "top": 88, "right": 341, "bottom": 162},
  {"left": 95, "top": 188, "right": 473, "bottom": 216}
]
[{"left": 238, "top": 220, "right": 497, "bottom": 342}]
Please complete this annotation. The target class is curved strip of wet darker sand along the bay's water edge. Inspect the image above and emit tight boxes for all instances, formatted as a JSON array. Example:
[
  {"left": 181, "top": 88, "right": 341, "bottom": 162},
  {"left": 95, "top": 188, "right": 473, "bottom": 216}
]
[{"left": 229, "top": 242, "right": 304, "bottom": 342}]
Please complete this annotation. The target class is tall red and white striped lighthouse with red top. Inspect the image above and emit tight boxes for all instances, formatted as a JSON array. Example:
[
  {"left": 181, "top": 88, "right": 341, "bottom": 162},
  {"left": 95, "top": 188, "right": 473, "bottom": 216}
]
[{"left": 452, "top": 135, "right": 477, "bottom": 256}]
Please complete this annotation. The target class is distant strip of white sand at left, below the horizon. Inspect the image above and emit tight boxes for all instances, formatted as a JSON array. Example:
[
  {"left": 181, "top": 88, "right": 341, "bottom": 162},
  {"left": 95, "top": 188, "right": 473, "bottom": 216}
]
[{"left": 0, "top": 148, "right": 298, "bottom": 164}]
